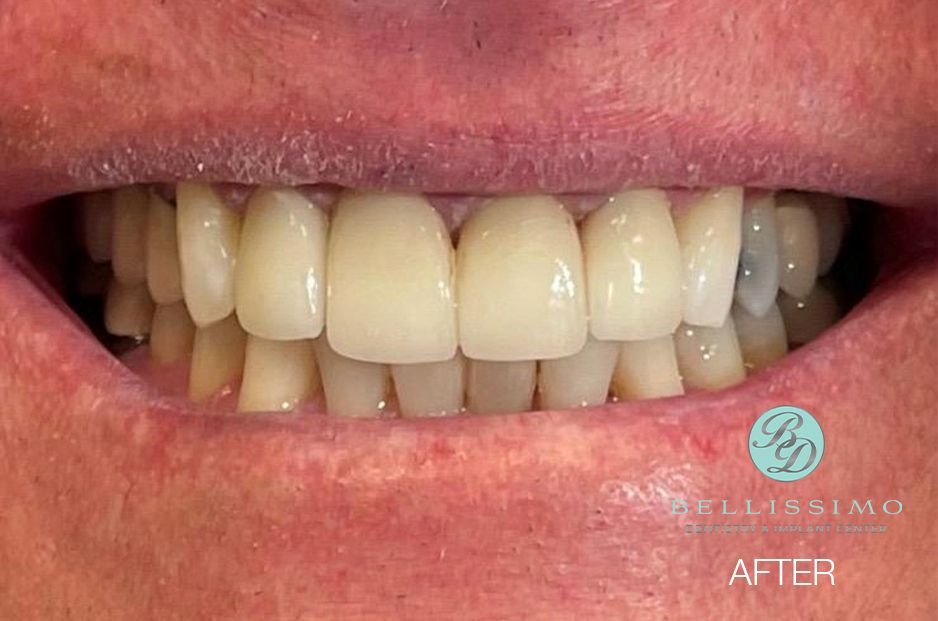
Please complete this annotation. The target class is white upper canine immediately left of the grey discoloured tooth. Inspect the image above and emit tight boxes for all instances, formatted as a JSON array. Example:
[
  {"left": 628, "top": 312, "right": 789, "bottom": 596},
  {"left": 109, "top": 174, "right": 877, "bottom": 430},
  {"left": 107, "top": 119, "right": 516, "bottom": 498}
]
[{"left": 675, "top": 187, "right": 743, "bottom": 327}]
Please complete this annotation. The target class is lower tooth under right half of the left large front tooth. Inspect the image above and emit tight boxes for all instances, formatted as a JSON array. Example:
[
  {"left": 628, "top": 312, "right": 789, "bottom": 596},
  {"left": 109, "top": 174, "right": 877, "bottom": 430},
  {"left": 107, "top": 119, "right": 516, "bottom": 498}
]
[{"left": 391, "top": 352, "right": 466, "bottom": 416}]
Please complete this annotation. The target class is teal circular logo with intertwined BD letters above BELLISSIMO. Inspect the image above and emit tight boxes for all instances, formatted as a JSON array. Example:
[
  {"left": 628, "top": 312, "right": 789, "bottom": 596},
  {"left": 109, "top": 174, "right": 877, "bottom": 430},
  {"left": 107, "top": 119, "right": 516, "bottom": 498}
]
[{"left": 749, "top": 405, "right": 824, "bottom": 481}]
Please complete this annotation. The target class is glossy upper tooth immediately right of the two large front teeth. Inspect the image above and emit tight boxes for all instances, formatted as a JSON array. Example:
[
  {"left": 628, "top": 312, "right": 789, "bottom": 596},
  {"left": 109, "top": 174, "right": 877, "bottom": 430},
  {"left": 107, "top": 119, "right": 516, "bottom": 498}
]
[{"left": 582, "top": 190, "right": 681, "bottom": 341}]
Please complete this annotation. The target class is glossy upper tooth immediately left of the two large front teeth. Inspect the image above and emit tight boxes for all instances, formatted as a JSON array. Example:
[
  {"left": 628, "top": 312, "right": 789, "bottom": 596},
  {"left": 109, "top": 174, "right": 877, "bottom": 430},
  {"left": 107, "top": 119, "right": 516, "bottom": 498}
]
[{"left": 235, "top": 188, "right": 329, "bottom": 340}]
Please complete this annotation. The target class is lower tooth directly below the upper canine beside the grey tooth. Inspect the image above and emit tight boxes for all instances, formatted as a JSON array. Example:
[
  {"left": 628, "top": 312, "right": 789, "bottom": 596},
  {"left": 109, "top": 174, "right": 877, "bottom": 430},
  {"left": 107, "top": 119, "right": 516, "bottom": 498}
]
[{"left": 674, "top": 316, "right": 746, "bottom": 390}]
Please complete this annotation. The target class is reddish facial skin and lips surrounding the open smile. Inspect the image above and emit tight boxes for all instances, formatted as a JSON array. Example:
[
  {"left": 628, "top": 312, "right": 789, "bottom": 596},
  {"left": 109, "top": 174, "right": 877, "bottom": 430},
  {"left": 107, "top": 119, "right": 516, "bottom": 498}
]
[{"left": 0, "top": 0, "right": 938, "bottom": 619}]
